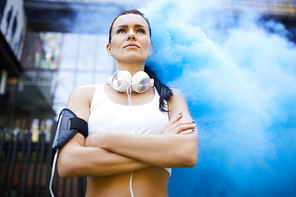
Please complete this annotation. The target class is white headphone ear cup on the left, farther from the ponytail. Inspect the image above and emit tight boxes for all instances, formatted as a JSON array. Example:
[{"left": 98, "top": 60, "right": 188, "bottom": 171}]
[{"left": 108, "top": 70, "right": 132, "bottom": 92}]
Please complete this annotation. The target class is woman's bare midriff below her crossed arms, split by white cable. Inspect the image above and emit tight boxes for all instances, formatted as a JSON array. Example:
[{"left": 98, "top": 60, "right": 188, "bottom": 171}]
[{"left": 86, "top": 167, "right": 169, "bottom": 197}]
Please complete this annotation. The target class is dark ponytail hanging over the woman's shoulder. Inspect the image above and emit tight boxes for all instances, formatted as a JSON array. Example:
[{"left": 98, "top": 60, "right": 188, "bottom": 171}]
[{"left": 144, "top": 66, "right": 173, "bottom": 112}]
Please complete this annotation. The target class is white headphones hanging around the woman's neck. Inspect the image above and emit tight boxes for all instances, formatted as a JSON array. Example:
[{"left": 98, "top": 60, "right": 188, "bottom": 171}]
[{"left": 106, "top": 70, "right": 154, "bottom": 93}]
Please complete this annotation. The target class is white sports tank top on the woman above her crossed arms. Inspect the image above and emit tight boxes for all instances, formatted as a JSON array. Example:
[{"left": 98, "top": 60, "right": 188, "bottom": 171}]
[{"left": 88, "top": 84, "right": 169, "bottom": 135}]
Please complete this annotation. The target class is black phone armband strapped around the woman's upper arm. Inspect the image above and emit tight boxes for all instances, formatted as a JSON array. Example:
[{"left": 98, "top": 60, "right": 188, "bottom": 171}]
[{"left": 52, "top": 108, "right": 88, "bottom": 164}]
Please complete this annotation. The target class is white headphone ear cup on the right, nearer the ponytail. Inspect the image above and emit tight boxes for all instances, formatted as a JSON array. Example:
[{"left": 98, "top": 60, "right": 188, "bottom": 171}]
[{"left": 132, "top": 71, "right": 154, "bottom": 93}]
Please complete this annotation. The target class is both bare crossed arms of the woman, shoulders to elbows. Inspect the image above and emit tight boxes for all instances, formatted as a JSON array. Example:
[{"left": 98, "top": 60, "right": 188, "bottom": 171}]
[{"left": 58, "top": 87, "right": 198, "bottom": 178}]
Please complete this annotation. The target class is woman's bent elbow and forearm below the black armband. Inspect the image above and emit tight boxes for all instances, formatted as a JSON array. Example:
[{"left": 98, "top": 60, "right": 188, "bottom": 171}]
[{"left": 58, "top": 134, "right": 150, "bottom": 178}]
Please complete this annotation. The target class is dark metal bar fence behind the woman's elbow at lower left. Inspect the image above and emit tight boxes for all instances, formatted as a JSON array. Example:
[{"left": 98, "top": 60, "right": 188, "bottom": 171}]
[{"left": 0, "top": 130, "right": 86, "bottom": 197}]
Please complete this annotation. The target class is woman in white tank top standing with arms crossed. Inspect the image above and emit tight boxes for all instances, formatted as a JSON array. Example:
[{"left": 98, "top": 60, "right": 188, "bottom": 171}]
[{"left": 58, "top": 9, "right": 198, "bottom": 197}]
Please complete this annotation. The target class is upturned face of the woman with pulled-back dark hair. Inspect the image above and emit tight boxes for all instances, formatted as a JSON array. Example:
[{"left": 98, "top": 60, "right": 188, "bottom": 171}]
[{"left": 106, "top": 14, "right": 152, "bottom": 63}]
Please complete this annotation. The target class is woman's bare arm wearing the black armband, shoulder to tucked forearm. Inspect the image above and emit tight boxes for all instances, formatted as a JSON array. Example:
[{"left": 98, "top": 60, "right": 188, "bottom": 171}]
[{"left": 57, "top": 86, "right": 150, "bottom": 178}]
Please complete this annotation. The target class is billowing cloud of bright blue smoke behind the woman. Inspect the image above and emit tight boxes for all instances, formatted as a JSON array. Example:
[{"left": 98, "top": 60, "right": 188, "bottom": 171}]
[{"left": 141, "top": 0, "right": 296, "bottom": 197}]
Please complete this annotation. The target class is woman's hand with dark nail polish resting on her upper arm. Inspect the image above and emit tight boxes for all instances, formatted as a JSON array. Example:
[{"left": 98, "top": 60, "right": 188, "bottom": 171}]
[{"left": 161, "top": 113, "right": 196, "bottom": 134}]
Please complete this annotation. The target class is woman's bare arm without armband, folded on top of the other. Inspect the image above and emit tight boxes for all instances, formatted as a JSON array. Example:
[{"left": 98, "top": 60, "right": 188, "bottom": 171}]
[{"left": 89, "top": 90, "right": 198, "bottom": 167}]
